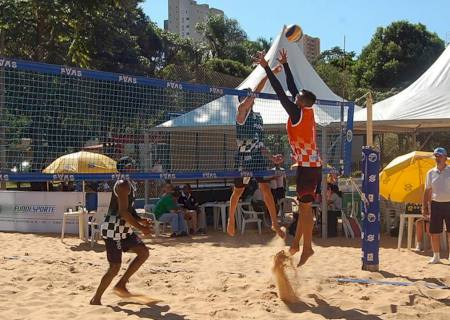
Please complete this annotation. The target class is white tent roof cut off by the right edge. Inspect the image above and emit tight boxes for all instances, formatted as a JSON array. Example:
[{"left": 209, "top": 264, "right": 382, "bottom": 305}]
[{"left": 354, "top": 47, "right": 450, "bottom": 130}]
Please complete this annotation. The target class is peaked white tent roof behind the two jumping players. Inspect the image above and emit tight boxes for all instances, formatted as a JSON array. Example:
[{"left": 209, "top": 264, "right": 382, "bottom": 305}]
[{"left": 158, "top": 27, "right": 358, "bottom": 129}]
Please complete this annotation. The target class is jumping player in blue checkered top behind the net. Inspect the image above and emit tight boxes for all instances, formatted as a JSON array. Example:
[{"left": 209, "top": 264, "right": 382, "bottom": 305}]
[{"left": 227, "top": 66, "right": 285, "bottom": 238}]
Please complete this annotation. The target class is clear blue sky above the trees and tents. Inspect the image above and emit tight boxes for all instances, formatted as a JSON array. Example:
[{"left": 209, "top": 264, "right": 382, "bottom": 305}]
[{"left": 142, "top": 0, "right": 450, "bottom": 53}]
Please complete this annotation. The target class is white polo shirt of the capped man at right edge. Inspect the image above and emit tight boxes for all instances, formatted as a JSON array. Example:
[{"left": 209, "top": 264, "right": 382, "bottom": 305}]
[{"left": 425, "top": 165, "right": 450, "bottom": 202}]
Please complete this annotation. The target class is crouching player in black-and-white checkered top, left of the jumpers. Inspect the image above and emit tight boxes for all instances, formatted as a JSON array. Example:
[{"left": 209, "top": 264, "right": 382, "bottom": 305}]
[{"left": 90, "top": 157, "right": 150, "bottom": 305}]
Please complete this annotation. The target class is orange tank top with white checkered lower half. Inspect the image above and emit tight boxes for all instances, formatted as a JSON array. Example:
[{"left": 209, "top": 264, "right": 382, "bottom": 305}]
[{"left": 286, "top": 107, "right": 322, "bottom": 167}]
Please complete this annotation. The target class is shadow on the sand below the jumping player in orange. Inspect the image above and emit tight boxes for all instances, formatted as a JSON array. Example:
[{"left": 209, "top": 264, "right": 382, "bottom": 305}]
[{"left": 286, "top": 294, "right": 381, "bottom": 320}]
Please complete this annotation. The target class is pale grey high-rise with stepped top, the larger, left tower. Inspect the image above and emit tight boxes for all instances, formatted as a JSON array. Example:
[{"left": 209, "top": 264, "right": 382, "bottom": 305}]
[{"left": 164, "top": 0, "right": 224, "bottom": 41}]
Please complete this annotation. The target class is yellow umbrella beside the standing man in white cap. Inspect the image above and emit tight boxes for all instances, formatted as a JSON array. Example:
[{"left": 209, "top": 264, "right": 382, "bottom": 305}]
[{"left": 380, "top": 151, "right": 450, "bottom": 203}]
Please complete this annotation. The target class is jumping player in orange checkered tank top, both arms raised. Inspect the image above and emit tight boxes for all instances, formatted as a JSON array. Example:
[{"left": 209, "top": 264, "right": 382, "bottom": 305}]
[{"left": 256, "top": 49, "right": 322, "bottom": 266}]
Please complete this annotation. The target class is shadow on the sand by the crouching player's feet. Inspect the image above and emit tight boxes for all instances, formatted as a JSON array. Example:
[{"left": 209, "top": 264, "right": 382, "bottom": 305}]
[{"left": 108, "top": 302, "right": 187, "bottom": 320}]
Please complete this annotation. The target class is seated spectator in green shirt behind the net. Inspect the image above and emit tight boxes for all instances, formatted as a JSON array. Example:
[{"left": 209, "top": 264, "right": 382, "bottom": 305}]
[{"left": 154, "top": 190, "right": 187, "bottom": 237}]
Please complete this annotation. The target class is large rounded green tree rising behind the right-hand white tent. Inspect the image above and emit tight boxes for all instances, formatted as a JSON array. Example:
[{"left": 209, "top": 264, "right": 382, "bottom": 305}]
[{"left": 354, "top": 21, "right": 445, "bottom": 88}]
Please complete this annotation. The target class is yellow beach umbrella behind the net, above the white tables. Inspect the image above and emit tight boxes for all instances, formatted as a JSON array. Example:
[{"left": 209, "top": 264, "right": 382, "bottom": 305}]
[{"left": 43, "top": 151, "right": 117, "bottom": 173}]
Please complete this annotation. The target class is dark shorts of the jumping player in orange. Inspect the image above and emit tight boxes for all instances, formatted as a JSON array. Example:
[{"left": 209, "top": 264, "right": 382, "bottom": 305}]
[{"left": 295, "top": 166, "right": 322, "bottom": 203}]
